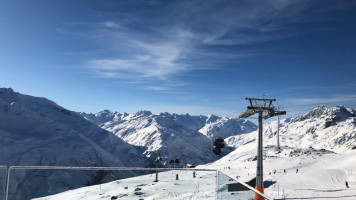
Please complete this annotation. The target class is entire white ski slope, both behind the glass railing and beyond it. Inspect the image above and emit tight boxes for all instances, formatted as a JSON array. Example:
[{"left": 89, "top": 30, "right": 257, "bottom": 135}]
[{"left": 36, "top": 147, "right": 356, "bottom": 200}]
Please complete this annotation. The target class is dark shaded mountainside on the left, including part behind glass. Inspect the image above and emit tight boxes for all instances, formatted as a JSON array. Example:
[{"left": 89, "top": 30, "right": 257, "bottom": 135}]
[{"left": 0, "top": 88, "right": 145, "bottom": 199}]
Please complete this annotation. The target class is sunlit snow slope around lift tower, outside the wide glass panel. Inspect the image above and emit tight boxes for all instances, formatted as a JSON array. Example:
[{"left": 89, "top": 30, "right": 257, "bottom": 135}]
[{"left": 203, "top": 143, "right": 356, "bottom": 200}]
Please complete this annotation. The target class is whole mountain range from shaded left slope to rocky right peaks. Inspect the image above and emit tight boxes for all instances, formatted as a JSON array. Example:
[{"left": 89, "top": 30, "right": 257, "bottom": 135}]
[{"left": 0, "top": 88, "right": 356, "bottom": 199}]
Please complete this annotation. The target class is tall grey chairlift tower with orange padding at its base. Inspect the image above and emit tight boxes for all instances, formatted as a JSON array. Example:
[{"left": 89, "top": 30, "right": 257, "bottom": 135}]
[{"left": 239, "top": 97, "right": 286, "bottom": 200}]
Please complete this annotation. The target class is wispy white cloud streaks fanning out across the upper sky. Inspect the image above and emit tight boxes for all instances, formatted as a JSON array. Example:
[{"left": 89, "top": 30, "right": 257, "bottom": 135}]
[{"left": 60, "top": 0, "right": 353, "bottom": 90}]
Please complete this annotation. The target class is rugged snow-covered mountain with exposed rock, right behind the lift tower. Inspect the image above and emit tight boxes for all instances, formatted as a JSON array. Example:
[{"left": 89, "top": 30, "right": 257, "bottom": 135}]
[{"left": 225, "top": 106, "right": 356, "bottom": 152}]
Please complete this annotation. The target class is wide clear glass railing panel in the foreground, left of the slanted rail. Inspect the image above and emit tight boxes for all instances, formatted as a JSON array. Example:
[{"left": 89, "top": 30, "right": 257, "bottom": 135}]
[{"left": 8, "top": 169, "right": 216, "bottom": 200}]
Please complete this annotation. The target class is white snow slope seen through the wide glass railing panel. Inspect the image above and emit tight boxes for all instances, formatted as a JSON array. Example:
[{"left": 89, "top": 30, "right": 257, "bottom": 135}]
[{"left": 32, "top": 171, "right": 216, "bottom": 200}]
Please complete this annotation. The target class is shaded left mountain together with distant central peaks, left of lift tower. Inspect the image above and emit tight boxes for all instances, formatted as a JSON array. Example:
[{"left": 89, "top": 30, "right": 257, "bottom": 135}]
[{"left": 0, "top": 88, "right": 256, "bottom": 199}]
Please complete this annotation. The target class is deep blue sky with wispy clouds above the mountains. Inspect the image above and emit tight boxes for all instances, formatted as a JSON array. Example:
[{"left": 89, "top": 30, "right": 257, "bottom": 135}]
[{"left": 0, "top": 0, "right": 356, "bottom": 117}]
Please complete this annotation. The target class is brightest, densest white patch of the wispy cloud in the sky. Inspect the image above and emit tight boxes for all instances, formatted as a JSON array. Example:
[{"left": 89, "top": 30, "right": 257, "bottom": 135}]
[{"left": 88, "top": 41, "right": 188, "bottom": 80}]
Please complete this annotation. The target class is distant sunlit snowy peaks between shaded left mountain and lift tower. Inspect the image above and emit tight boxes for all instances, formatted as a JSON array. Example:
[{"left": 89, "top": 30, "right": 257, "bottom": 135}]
[{"left": 80, "top": 110, "right": 257, "bottom": 166}]
